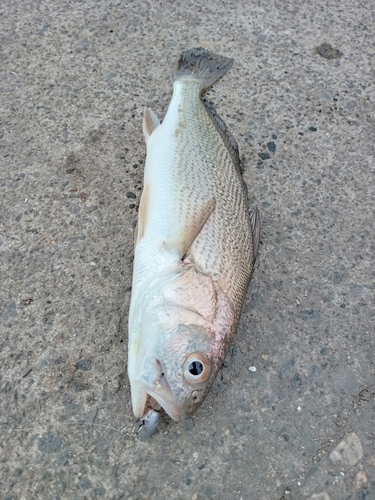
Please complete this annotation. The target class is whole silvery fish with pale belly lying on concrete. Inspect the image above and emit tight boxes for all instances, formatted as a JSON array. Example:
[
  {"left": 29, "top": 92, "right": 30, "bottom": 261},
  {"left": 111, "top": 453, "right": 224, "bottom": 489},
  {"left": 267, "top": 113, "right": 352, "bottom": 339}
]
[{"left": 128, "top": 47, "right": 260, "bottom": 424}]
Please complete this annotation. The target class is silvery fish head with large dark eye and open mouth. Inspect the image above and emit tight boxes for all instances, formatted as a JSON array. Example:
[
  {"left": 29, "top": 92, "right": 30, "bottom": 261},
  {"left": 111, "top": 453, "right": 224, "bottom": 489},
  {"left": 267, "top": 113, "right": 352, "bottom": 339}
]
[{"left": 129, "top": 307, "right": 223, "bottom": 421}]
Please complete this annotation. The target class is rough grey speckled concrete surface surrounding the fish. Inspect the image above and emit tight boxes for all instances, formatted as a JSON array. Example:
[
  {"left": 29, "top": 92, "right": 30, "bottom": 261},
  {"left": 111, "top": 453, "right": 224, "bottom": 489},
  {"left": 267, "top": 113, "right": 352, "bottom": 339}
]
[{"left": 0, "top": 0, "right": 375, "bottom": 500}]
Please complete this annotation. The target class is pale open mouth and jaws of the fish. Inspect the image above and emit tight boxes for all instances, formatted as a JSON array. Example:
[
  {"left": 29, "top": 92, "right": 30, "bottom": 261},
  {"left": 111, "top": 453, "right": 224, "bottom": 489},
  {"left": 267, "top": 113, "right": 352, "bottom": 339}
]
[{"left": 132, "top": 360, "right": 181, "bottom": 422}]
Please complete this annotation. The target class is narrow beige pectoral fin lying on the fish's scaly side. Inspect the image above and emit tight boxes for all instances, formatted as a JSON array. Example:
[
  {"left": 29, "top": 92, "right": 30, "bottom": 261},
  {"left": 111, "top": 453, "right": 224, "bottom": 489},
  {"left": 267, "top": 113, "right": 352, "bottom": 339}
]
[{"left": 166, "top": 198, "right": 216, "bottom": 259}]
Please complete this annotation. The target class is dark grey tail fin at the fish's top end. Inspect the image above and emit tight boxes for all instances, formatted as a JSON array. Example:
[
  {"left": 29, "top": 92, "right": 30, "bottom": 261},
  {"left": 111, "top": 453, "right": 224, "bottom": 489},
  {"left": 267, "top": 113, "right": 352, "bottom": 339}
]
[{"left": 173, "top": 47, "right": 233, "bottom": 91}]
